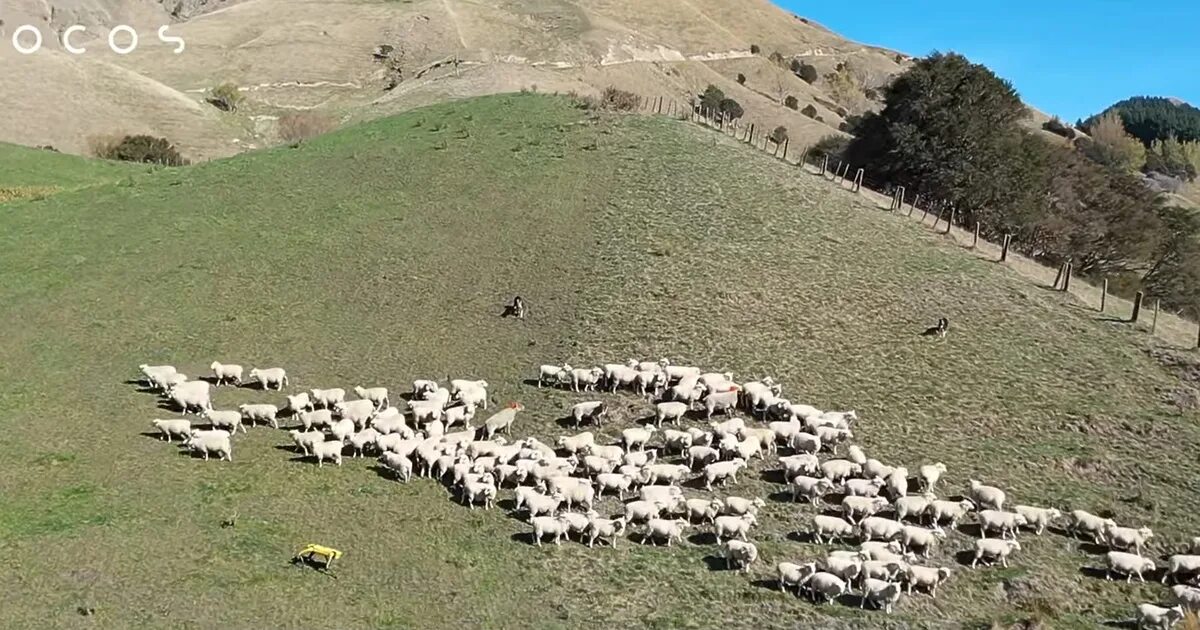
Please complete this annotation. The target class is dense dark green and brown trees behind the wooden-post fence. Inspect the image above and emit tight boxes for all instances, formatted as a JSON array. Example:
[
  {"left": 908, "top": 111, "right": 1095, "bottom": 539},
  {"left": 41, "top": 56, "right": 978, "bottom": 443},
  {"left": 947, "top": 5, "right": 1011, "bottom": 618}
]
[{"left": 841, "top": 53, "right": 1200, "bottom": 312}]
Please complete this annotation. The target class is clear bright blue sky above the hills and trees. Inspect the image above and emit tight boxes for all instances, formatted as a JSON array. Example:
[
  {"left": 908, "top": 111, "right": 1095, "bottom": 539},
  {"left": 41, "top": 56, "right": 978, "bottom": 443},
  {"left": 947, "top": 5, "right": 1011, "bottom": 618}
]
[{"left": 775, "top": 0, "right": 1200, "bottom": 121}]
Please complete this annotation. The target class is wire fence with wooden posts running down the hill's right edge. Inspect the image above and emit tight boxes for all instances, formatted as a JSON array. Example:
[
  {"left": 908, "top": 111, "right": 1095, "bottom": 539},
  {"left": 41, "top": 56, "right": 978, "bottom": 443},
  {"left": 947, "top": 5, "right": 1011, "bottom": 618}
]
[{"left": 638, "top": 96, "right": 1200, "bottom": 348}]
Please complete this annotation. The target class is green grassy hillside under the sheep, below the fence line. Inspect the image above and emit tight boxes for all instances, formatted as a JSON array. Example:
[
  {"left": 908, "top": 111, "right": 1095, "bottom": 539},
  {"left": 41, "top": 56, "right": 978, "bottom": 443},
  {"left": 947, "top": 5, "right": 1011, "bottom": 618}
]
[{"left": 0, "top": 96, "right": 1200, "bottom": 628}]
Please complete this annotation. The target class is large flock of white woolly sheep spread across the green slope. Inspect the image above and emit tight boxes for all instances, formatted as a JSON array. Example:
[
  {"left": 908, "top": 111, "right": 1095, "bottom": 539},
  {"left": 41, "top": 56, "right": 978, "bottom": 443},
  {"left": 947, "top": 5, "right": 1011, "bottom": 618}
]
[{"left": 140, "top": 359, "right": 1200, "bottom": 628}]
